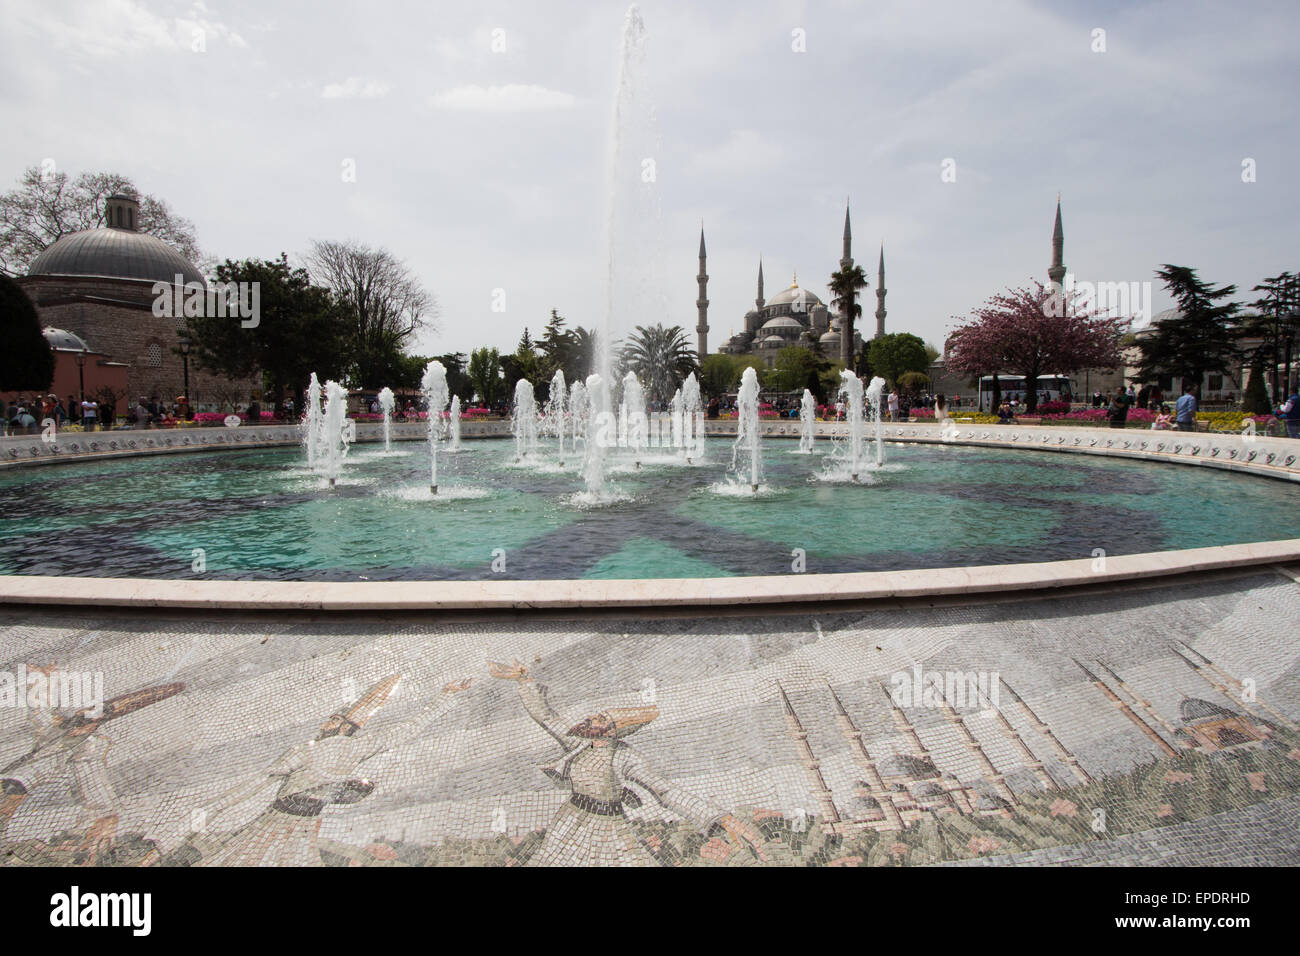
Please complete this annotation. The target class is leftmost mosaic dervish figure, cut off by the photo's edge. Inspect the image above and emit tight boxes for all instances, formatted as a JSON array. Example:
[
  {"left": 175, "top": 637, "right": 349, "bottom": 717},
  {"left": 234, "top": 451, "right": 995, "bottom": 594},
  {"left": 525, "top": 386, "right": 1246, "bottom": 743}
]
[{"left": 0, "top": 667, "right": 185, "bottom": 864}]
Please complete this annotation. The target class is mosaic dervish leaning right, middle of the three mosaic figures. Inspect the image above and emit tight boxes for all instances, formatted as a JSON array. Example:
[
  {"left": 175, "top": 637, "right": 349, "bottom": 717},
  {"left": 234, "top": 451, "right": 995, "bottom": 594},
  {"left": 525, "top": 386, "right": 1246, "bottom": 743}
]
[{"left": 198, "top": 674, "right": 471, "bottom": 866}]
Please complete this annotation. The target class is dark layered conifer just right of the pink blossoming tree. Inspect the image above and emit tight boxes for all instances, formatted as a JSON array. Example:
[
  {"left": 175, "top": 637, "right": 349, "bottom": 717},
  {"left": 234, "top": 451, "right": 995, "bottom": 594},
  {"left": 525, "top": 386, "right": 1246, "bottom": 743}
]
[{"left": 1134, "top": 264, "right": 1240, "bottom": 385}]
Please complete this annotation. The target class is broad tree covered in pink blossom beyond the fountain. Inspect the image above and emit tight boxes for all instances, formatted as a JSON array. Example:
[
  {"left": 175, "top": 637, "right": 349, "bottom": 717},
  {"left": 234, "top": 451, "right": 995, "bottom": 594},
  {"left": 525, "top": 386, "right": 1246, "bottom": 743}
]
[{"left": 948, "top": 282, "right": 1128, "bottom": 414}]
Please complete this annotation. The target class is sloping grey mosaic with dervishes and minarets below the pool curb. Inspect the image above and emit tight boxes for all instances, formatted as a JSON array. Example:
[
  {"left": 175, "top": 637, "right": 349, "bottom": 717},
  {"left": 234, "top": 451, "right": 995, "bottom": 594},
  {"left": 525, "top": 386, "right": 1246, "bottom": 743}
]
[{"left": 0, "top": 572, "right": 1300, "bottom": 866}]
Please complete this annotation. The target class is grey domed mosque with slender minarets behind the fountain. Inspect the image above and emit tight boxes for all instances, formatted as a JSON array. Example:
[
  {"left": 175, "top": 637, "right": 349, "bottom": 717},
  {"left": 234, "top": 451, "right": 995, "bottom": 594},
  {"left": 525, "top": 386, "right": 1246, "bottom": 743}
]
[{"left": 696, "top": 202, "right": 885, "bottom": 365}]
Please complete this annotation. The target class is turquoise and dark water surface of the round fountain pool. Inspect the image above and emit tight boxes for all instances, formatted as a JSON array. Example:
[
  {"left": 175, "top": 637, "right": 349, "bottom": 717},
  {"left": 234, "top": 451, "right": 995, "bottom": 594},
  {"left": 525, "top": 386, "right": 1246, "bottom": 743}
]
[{"left": 0, "top": 440, "right": 1300, "bottom": 581}]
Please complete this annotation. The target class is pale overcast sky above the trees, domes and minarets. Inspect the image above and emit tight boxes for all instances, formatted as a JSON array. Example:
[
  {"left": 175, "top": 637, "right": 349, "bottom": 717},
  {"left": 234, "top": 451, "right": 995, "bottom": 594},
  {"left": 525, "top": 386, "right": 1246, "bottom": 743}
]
[{"left": 0, "top": 0, "right": 1300, "bottom": 352}]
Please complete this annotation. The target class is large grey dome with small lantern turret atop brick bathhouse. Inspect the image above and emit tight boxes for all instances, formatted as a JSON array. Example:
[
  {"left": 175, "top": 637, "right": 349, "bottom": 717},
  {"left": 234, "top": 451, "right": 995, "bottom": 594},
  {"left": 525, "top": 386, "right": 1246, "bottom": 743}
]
[{"left": 27, "top": 195, "right": 205, "bottom": 285}]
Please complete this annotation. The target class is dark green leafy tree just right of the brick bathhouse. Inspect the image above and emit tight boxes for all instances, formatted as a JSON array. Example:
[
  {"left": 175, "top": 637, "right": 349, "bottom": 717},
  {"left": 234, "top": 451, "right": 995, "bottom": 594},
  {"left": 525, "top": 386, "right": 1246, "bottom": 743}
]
[{"left": 185, "top": 252, "right": 350, "bottom": 407}]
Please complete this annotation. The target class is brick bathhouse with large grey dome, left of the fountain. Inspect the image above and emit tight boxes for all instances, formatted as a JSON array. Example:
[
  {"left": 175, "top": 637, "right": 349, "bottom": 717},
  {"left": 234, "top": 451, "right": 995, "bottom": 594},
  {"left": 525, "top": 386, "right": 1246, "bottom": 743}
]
[{"left": 17, "top": 194, "right": 261, "bottom": 406}]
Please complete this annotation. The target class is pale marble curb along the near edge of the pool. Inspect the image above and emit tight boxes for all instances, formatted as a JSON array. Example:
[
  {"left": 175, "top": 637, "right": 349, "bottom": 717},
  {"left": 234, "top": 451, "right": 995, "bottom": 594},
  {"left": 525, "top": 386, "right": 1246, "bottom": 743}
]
[{"left": 0, "top": 538, "right": 1300, "bottom": 611}]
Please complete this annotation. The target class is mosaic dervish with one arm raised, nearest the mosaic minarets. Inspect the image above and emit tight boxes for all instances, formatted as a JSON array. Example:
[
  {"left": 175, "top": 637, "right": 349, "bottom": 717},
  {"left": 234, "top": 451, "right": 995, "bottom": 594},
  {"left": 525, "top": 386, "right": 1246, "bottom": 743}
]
[{"left": 488, "top": 661, "right": 767, "bottom": 866}]
